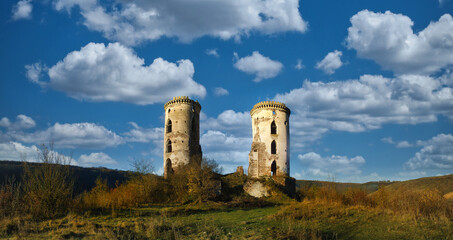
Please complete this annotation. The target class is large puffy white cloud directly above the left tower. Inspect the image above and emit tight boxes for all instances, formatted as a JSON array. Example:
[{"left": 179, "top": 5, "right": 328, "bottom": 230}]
[{"left": 26, "top": 43, "right": 206, "bottom": 105}]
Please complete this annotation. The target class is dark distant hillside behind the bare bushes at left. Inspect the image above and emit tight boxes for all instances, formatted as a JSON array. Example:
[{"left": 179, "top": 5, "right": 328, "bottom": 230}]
[{"left": 0, "top": 160, "right": 132, "bottom": 193}]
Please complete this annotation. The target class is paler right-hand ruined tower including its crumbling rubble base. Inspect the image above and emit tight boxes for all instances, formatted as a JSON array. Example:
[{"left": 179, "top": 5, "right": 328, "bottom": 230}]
[{"left": 244, "top": 101, "right": 296, "bottom": 197}]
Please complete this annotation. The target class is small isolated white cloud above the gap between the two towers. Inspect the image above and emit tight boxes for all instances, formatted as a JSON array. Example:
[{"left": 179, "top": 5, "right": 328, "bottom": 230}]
[{"left": 234, "top": 51, "right": 283, "bottom": 82}]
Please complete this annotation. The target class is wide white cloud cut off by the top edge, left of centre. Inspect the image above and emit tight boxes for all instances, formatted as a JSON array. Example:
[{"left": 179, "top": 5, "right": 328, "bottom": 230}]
[{"left": 54, "top": 0, "right": 307, "bottom": 45}]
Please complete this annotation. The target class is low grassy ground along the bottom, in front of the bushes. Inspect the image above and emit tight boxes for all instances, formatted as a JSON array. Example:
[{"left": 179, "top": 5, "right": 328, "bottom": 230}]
[{"left": 0, "top": 201, "right": 453, "bottom": 239}]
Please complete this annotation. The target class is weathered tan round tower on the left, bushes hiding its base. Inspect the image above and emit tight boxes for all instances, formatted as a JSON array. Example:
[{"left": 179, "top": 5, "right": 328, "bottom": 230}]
[{"left": 164, "top": 96, "right": 202, "bottom": 177}]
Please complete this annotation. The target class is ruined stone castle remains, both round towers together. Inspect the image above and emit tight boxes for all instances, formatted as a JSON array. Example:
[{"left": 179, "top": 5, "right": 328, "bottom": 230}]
[{"left": 164, "top": 96, "right": 296, "bottom": 197}]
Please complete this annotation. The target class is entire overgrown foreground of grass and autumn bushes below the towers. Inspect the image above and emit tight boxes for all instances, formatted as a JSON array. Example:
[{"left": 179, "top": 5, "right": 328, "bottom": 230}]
[{"left": 0, "top": 156, "right": 453, "bottom": 240}]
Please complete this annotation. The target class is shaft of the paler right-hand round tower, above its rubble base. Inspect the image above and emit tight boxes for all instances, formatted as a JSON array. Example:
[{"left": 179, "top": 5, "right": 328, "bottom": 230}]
[{"left": 248, "top": 101, "right": 291, "bottom": 178}]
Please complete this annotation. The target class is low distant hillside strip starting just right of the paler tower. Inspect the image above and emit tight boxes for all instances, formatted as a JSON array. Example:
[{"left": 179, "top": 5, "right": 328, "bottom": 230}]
[{"left": 296, "top": 180, "right": 395, "bottom": 193}]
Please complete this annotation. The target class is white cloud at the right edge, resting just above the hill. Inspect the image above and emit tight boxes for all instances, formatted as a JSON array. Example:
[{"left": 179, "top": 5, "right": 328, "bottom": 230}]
[{"left": 405, "top": 134, "right": 453, "bottom": 170}]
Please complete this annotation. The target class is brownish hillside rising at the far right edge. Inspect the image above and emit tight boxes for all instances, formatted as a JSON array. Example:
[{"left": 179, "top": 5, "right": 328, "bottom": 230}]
[{"left": 385, "top": 174, "right": 453, "bottom": 195}]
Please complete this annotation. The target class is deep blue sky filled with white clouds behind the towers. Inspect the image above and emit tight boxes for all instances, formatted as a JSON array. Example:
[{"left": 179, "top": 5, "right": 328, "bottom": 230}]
[{"left": 0, "top": 0, "right": 453, "bottom": 182}]
